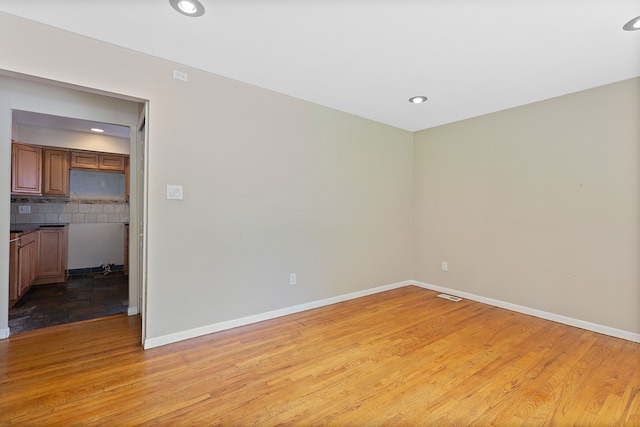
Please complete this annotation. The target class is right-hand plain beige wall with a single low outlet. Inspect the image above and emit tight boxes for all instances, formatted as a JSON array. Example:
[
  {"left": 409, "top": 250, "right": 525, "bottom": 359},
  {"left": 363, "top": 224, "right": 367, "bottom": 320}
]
[{"left": 413, "top": 79, "right": 640, "bottom": 333}]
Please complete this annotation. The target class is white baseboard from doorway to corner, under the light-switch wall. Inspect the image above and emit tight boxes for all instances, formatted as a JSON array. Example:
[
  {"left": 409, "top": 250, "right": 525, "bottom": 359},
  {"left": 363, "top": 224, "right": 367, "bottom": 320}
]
[{"left": 144, "top": 281, "right": 413, "bottom": 349}]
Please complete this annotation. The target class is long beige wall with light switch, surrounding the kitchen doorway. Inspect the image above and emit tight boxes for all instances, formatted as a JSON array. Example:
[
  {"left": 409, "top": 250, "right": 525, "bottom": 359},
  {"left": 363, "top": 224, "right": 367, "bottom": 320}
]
[{"left": 0, "top": 13, "right": 413, "bottom": 338}]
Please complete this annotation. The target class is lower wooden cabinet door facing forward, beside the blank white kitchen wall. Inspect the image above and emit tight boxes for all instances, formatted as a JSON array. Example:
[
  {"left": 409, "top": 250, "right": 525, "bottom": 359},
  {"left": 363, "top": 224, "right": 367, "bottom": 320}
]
[{"left": 36, "top": 227, "right": 67, "bottom": 284}]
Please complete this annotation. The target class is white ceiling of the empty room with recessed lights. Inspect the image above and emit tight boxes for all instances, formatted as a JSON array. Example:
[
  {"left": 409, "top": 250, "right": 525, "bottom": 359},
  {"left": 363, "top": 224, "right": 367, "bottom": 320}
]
[{"left": 0, "top": 0, "right": 640, "bottom": 131}]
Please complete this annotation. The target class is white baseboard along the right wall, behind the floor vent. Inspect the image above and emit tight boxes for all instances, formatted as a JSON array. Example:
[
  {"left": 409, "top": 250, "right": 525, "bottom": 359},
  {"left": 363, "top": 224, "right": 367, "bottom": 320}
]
[{"left": 408, "top": 280, "right": 640, "bottom": 342}]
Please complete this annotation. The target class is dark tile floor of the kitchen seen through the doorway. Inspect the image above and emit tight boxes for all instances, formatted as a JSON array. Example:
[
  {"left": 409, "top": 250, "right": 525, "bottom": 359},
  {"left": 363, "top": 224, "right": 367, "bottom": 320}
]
[{"left": 9, "top": 274, "right": 129, "bottom": 335}]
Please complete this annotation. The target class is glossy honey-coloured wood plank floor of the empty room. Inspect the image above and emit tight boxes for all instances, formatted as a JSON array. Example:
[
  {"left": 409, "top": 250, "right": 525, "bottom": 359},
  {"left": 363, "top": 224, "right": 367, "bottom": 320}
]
[{"left": 0, "top": 286, "right": 640, "bottom": 426}]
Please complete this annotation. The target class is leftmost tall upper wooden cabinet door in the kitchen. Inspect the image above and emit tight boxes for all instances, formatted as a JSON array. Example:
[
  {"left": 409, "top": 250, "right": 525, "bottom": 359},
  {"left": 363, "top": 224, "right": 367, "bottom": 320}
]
[{"left": 11, "top": 142, "right": 42, "bottom": 194}]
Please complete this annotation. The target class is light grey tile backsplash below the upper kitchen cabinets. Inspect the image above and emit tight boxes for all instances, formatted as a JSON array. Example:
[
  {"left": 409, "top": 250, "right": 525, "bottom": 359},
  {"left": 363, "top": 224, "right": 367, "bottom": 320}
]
[{"left": 10, "top": 196, "right": 129, "bottom": 224}]
